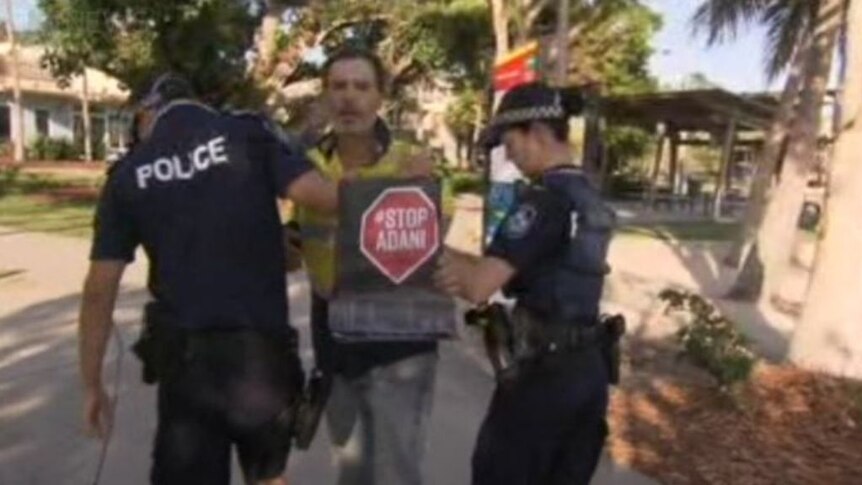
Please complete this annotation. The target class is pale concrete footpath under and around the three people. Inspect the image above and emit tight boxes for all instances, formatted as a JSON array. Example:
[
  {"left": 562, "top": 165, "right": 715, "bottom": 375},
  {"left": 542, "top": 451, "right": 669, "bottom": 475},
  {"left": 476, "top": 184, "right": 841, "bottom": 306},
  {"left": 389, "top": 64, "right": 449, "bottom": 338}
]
[{"left": 0, "top": 228, "right": 655, "bottom": 485}]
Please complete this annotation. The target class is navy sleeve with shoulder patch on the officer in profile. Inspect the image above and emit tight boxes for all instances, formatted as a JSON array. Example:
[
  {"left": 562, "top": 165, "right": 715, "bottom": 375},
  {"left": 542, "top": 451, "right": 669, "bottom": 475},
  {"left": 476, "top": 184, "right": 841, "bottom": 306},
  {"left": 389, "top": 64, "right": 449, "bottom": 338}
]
[{"left": 486, "top": 189, "right": 570, "bottom": 271}]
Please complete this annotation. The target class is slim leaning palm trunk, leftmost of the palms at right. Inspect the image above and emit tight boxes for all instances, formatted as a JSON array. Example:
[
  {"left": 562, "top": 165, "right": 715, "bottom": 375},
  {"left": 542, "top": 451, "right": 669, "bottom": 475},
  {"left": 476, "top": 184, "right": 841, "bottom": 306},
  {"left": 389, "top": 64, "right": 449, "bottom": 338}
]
[{"left": 724, "top": 30, "right": 811, "bottom": 272}]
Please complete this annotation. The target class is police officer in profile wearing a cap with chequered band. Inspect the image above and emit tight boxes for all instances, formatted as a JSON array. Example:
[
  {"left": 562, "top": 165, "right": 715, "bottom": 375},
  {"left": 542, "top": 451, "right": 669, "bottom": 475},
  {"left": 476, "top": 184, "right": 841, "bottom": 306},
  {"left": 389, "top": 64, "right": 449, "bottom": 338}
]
[{"left": 435, "top": 83, "right": 613, "bottom": 485}]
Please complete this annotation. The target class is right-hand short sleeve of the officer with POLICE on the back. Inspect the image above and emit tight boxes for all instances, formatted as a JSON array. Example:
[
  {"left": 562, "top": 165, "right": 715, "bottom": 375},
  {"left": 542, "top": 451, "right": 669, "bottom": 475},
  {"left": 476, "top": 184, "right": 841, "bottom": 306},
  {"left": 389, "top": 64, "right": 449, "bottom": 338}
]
[{"left": 258, "top": 119, "right": 314, "bottom": 197}]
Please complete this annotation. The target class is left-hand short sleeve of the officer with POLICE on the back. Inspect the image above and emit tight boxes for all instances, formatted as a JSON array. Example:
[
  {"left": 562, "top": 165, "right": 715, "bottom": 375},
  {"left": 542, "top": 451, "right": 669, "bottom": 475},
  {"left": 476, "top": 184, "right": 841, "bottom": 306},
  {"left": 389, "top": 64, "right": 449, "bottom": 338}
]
[{"left": 90, "top": 173, "right": 139, "bottom": 262}]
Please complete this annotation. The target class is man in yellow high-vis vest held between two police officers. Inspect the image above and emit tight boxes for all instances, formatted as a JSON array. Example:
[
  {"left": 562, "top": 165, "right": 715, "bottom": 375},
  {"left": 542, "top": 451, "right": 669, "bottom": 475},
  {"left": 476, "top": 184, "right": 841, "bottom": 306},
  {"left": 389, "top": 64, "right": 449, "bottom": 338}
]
[{"left": 296, "top": 49, "right": 438, "bottom": 485}]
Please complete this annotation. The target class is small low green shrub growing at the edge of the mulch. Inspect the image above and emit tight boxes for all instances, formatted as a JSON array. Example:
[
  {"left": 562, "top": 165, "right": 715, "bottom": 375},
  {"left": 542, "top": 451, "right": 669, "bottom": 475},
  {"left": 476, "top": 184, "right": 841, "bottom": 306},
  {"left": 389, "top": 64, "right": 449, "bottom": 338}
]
[{"left": 659, "top": 289, "right": 756, "bottom": 388}]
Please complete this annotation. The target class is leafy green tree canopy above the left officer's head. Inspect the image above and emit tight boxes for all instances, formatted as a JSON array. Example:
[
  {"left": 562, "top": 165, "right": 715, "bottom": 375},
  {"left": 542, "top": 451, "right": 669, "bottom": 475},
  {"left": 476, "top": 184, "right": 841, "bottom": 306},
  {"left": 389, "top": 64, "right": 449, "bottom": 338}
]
[{"left": 39, "top": 0, "right": 260, "bottom": 99}]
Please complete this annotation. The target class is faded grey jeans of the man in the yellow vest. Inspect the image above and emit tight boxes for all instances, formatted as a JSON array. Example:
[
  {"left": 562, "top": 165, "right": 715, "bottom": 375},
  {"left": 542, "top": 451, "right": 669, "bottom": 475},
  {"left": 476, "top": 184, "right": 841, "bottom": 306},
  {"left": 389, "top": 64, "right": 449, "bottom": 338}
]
[{"left": 326, "top": 352, "right": 438, "bottom": 485}]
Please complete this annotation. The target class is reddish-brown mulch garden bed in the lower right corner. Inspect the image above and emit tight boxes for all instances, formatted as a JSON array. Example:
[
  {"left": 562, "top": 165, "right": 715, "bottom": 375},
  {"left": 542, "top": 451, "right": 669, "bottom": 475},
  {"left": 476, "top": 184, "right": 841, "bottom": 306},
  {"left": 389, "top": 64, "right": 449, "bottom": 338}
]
[{"left": 609, "top": 343, "right": 862, "bottom": 485}]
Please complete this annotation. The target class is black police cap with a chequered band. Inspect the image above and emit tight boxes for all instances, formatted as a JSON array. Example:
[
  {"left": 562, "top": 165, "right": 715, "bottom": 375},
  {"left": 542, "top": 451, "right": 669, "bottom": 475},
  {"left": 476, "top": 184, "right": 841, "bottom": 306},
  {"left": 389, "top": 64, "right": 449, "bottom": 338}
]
[{"left": 480, "top": 82, "right": 584, "bottom": 149}]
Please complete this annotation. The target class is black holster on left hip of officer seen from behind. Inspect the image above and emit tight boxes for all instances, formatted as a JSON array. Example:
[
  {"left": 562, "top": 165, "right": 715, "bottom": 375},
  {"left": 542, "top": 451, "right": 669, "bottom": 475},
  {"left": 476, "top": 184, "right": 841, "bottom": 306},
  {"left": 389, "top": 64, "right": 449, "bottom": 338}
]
[{"left": 132, "top": 302, "right": 187, "bottom": 384}]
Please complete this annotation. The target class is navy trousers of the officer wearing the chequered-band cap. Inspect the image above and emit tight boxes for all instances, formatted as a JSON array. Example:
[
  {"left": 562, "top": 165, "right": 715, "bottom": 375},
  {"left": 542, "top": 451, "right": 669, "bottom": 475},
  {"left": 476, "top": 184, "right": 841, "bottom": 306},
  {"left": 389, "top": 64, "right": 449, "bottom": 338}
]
[{"left": 473, "top": 348, "right": 608, "bottom": 485}]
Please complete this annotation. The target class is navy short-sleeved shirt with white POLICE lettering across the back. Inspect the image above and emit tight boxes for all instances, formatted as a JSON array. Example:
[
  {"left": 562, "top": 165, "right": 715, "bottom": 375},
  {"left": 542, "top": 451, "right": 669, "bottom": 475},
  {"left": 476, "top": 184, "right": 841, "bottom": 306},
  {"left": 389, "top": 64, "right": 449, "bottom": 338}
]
[{"left": 91, "top": 101, "right": 313, "bottom": 330}]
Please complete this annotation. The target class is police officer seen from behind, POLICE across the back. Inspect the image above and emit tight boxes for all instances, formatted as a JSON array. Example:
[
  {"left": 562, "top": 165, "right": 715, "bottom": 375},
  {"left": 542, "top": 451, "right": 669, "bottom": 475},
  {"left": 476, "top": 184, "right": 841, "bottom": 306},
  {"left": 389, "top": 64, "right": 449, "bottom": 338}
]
[{"left": 79, "top": 74, "right": 337, "bottom": 485}]
